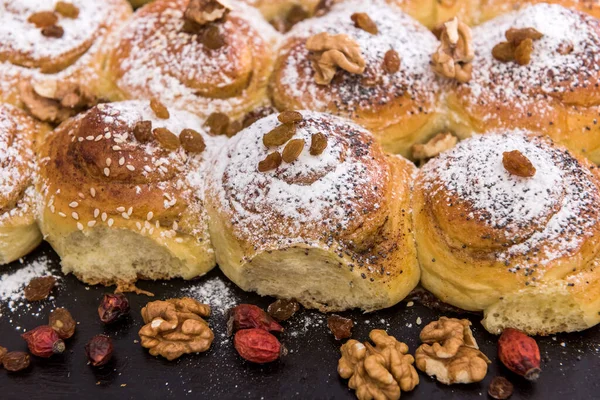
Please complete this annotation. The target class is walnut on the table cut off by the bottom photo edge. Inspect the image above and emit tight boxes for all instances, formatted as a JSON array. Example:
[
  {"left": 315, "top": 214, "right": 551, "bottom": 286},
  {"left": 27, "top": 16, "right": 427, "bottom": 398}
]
[{"left": 338, "top": 329, "right": 419, "bottom": 400}]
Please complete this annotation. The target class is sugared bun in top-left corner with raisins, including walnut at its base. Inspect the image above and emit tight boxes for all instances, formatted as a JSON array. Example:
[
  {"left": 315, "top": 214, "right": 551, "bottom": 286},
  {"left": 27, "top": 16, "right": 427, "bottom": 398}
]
[{"left": 0, "top": 0, "right": 131, "bottom": 122}]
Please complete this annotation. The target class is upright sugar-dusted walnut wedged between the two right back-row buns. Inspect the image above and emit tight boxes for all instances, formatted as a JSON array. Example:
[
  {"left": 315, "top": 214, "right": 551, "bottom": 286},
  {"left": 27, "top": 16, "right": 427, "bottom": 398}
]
[{"left": 431, "top": 17, "right": 475, "bottom": 83}]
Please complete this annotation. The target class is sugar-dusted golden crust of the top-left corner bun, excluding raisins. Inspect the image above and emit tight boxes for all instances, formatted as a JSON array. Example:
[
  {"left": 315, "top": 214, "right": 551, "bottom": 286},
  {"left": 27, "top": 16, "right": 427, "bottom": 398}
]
[{"left": 0, "top": 0, "right": 131, "bottom": 115}]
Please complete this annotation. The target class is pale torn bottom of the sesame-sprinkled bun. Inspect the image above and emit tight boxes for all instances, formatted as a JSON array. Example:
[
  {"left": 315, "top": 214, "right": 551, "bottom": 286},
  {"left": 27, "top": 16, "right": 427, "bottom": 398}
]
[{"left": 40, "top": 212, "right": 216, "bottom": 286}]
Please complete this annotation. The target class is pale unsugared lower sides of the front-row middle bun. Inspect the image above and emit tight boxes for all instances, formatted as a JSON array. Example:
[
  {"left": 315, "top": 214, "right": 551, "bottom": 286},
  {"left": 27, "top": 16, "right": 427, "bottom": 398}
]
[{"left": 207, "top": 157, "right": 420, "bottom": 312}]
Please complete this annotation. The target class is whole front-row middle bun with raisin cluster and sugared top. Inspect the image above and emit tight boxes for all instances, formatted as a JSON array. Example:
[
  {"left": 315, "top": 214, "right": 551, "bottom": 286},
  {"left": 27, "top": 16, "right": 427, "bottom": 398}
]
[{"left": 206, "top": 111, "right": 419, "bottom": 311}]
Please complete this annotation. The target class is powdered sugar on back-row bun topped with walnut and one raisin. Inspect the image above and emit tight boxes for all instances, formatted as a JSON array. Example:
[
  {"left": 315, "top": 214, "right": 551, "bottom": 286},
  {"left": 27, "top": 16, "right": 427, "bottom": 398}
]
[{"left": 278, "top": 0, "right": 439, "bottom": 115}]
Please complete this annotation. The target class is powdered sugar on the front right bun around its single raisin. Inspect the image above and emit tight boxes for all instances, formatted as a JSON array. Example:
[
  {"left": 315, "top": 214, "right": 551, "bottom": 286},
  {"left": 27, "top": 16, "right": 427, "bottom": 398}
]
[{"left": 421, "top": 131, "right": 600, "bottom": 264}]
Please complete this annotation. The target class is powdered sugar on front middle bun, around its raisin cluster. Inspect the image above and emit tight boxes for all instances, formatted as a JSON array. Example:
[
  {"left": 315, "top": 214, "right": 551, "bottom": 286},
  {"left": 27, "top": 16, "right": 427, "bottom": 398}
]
[{"left": 208, "top": 111, "right": 389, "bottom": 243}]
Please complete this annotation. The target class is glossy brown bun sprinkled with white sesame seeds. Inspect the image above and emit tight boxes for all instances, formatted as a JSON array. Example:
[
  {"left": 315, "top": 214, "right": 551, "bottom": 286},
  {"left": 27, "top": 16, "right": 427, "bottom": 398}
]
[{"left": 38, "top": 101, "right": 224, "bottom": 285}]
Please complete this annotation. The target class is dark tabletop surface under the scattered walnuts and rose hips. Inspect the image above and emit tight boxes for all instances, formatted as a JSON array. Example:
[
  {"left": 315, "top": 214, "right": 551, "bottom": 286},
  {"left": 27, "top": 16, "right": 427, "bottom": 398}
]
[{"left": 0, "top": 244, "right": 600, "bottom": 400}]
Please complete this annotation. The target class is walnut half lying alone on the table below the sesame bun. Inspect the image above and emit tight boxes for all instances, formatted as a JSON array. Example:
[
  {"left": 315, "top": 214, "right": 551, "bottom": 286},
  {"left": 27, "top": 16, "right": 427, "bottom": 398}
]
[{"left": 139, "top": 297, "right": 214, "bottom": 361}]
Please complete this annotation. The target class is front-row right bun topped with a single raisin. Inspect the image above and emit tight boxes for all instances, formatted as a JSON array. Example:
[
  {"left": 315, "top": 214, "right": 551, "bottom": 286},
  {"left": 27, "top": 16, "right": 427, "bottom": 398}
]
[{"left": 413, "top": 130, "right": 600, "bottom": 334}]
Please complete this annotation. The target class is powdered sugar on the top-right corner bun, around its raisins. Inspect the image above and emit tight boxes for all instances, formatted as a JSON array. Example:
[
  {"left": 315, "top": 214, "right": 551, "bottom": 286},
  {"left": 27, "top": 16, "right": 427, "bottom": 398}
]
[{"left": 464, "top": 4, "right": 600, "bottom": 119}]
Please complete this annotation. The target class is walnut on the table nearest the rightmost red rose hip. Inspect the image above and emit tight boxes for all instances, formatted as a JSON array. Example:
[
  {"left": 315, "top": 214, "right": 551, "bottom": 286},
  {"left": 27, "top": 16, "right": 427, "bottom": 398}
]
[{"left": 415, "top": 317, "right": 490, "bottom": 385}]
